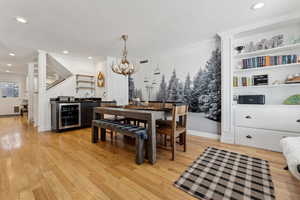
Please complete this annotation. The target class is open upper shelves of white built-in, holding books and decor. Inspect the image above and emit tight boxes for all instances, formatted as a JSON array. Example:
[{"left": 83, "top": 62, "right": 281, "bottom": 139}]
[{"left": 231, "top": 21, "right": 300, "bottom": 106}]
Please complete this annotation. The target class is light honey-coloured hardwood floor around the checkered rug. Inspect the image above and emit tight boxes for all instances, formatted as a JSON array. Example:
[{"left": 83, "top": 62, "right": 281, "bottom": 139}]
[{"left": 0, "top": 117, "right": 300, "bottom": 200}]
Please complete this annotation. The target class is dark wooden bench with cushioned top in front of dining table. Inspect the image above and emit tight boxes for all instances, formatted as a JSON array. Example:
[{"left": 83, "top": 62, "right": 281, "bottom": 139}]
[{"left": 92, "top": 119, "right": 148, "bottom": 164}]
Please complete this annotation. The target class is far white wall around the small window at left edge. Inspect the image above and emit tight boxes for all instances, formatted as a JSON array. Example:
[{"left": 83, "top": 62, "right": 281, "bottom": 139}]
[{"left": 0, "top": 73, "right": 26, "bottom": 115}]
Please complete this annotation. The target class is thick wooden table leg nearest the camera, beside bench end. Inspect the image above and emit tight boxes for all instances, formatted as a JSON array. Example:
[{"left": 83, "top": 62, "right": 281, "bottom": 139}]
[{"left": 147, "top": 117, "right": 156, "bottom": 164}]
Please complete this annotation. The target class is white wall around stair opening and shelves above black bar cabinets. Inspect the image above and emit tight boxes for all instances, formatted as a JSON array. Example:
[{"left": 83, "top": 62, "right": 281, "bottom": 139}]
[{"left": 38, "top": 51, "right": 128, "bottom": 131}]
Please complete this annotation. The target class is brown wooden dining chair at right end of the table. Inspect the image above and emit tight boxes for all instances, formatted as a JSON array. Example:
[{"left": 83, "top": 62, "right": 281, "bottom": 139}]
[{"left": 156, "top": 103, "right": 188, "bottom": 160}]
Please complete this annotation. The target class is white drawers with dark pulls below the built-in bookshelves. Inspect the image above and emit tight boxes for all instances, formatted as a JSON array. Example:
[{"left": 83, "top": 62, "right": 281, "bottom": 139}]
[{"left": 234, "top": 105, "right": 300, "bottom": 151}]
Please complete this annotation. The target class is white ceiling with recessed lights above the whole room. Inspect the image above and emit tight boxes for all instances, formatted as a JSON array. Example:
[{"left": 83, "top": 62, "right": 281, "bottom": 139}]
[{"left": 0, "top": 0, "right": 300, "bottom": 73}]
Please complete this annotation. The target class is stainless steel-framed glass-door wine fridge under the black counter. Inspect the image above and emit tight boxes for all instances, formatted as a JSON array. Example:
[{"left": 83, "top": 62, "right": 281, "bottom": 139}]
[{"left": 58, "top": 103, "right": 81, "bottom": 130}]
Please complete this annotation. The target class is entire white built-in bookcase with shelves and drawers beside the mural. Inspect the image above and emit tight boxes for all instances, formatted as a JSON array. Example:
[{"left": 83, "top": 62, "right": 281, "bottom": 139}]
[{"left": 220, "top": 14, "right": 300, "bottom": 148}]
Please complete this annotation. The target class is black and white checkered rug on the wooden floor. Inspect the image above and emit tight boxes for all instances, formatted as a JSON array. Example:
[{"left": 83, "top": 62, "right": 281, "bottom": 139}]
[{"left": 175, "top": 147, "right": 275, "bottom": 200}]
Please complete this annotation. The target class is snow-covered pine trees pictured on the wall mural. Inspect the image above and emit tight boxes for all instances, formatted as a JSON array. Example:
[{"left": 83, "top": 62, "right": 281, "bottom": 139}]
[{"left": 157, "top": 49, "right": 221, "bottom": 121}]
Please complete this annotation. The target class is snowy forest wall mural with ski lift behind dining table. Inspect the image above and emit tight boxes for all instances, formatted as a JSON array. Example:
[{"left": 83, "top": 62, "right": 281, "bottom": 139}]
[{"left": 129, "top": 37, "right": 221, "bottom": 134}]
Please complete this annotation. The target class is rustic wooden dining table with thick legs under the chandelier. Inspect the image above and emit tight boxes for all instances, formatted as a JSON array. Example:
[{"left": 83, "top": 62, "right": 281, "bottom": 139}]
[{"left": 93, "top": 107, "right": 167, "bottom": 164}]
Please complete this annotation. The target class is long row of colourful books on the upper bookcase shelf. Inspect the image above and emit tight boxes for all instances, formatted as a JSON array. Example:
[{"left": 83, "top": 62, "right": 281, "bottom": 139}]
[{"left": 242, "top": 55, "right": 300, "bottom": 69}]
